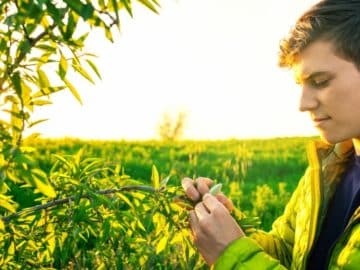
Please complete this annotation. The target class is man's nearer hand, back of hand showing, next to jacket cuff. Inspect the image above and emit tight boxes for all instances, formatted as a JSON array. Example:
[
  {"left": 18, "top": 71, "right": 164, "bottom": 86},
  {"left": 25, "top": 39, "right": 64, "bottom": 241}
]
[{"left": 190, "top": 193, "right": 245, "bottom": 265}]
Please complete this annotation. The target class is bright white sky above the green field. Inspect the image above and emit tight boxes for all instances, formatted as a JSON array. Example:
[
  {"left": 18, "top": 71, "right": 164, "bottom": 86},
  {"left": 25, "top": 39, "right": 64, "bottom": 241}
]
[{"left": 31, "top": 0, "right": 317, "bottom": 140}]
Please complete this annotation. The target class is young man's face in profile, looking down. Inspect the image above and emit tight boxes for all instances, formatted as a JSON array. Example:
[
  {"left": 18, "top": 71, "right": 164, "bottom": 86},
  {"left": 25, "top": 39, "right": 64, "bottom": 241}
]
[{"left": 293, "top": 41, "right": 360, "bottom": 143}]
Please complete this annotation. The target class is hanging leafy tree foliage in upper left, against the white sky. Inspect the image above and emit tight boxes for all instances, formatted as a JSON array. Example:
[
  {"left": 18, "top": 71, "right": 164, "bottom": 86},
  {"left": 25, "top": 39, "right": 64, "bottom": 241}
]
[{"left": 0, "top": 0, "right": 158, "bottom": 215}]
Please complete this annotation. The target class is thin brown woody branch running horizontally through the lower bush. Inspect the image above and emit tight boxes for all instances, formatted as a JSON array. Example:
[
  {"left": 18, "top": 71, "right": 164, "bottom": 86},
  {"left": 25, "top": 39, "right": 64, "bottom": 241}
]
[{"left": 1, "top": 186, "right": 159, "bottom": 223}]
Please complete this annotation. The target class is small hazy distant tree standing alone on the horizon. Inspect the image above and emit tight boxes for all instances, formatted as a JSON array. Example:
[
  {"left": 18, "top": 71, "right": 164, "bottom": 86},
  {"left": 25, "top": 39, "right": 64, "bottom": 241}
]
[{"left": 158, "top": 112, "right": 187, "bottom": 141}]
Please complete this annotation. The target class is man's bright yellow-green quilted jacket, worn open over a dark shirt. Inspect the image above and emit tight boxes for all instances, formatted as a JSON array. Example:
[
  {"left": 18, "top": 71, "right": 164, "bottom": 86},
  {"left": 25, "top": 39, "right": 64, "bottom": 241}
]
[{"left": 214, "top": 141, "right": 360, "bottom": 270}]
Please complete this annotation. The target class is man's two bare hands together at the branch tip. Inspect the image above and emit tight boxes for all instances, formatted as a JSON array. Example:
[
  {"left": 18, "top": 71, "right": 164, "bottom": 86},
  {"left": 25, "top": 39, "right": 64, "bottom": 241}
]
[{"left": 181, "top": 177, "right": 245, "bottom": 265}]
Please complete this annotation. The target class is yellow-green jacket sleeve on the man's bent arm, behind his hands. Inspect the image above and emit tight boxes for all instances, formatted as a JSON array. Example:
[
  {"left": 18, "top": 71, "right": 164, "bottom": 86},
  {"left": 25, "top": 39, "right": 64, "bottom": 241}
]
[{"left": 214, "top": 174, "right": 304, "bottom": 270}]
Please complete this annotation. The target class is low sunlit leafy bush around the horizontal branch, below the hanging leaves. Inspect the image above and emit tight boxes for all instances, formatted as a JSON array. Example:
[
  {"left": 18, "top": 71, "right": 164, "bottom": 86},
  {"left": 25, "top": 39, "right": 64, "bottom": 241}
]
[{"left": 0, "top": 151, "right": 202, "bottom": 269}]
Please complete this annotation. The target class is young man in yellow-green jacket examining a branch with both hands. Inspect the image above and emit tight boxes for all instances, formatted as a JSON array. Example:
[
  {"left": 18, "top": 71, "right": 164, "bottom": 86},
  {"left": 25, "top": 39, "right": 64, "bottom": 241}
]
[{"left": 182, "top": 0, "right": 360, "bottom": 270}]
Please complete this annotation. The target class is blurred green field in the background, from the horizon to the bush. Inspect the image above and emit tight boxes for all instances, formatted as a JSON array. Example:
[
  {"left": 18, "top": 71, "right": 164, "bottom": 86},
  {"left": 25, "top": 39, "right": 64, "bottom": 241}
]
[{"left": 27, "top": 137, "right": 314, "bottom": 230}]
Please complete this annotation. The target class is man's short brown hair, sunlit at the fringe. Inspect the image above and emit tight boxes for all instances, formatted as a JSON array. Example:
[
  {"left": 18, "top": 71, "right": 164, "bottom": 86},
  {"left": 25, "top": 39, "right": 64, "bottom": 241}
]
[{"left": 278, "top": 0, "right": 360, "bottom": 70}]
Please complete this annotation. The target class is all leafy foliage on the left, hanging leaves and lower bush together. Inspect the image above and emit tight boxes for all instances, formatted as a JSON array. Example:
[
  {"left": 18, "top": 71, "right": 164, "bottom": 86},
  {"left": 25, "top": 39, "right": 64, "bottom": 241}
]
[{"left": 0, "top": 0, "right": 210, "bottom": 269}]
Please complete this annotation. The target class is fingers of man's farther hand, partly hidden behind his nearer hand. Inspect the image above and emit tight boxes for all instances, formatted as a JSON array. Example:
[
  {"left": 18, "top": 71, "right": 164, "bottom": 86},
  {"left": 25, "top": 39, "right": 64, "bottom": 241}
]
[{"left": 181, "top": 177, "right": 234, "bottom": 212}]
